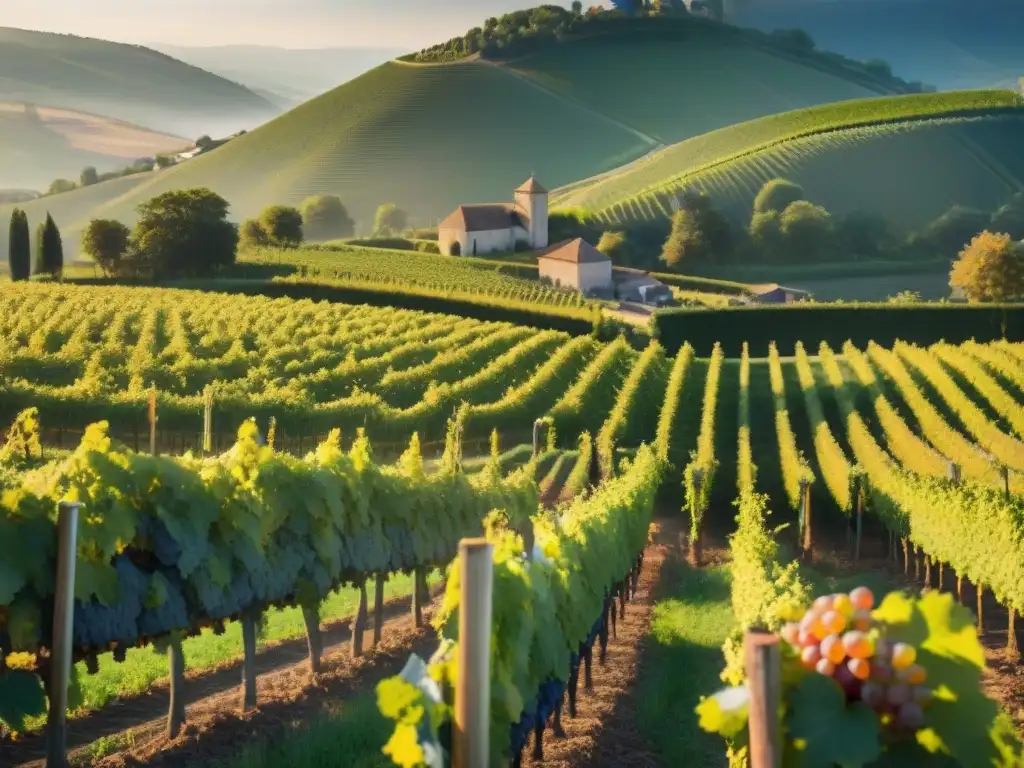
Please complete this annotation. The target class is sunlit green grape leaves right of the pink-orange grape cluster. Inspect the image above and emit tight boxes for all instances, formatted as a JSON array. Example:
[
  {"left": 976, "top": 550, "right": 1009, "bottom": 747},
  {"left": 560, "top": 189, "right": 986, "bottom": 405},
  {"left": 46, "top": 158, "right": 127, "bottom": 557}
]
[{"left": 874, "top": 592, "right": 999, "bottom": 765}]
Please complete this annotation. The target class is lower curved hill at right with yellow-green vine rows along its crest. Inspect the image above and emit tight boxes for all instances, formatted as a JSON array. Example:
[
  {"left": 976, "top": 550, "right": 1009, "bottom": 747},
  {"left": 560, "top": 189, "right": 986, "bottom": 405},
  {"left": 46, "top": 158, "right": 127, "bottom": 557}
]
[{"left": 552, "top": 91, "right": 1024, "bottom": 228}]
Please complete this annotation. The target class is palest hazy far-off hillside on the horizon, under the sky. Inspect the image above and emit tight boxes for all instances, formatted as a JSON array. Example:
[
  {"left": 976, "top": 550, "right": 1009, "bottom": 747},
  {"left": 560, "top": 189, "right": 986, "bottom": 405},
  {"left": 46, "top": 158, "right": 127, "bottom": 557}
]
[{"left": 151, "top": 43, "right": 406, "bottom": 105}]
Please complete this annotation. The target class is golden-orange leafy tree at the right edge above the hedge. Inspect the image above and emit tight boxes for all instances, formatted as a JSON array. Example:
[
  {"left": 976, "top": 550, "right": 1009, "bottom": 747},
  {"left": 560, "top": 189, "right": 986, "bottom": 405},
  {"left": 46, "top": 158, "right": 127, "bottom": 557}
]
[{"left": 949, "top": 231, "right": 1024, "bottom": 301}]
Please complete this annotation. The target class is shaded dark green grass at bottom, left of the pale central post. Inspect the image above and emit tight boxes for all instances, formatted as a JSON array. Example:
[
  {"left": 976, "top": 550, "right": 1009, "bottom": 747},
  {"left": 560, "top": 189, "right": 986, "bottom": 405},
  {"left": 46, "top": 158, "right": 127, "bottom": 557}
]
[{"left": 217, "top": 693, "right": 393, "bottom": 768}]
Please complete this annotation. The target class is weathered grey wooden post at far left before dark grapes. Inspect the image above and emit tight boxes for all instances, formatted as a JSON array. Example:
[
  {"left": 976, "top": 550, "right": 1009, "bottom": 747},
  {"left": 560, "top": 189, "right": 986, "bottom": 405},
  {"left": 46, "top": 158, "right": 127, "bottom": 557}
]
[{"left": 46, "top": 502, "right": 79, "bottom": 768}]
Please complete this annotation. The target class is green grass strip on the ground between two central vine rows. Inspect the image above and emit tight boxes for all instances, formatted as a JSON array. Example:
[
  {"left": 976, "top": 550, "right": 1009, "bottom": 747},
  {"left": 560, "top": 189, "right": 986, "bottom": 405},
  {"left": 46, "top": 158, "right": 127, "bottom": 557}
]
[{"left": 638, "top": 559, "right": 734, "bottom": 768}]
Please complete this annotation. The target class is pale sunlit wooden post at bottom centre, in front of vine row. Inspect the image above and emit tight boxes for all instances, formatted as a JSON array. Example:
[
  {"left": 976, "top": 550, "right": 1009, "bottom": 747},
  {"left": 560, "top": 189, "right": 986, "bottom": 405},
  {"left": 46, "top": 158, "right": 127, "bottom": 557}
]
[{"left": 452, "top": 539, "right": 494, "bottom": 768}]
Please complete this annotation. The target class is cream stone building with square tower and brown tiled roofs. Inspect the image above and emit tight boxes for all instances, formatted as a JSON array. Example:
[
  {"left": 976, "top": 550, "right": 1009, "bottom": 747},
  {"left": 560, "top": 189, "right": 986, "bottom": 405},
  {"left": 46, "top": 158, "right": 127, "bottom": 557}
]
[{"left": 437, "top": 176, "right": 548, "bottom": 256}]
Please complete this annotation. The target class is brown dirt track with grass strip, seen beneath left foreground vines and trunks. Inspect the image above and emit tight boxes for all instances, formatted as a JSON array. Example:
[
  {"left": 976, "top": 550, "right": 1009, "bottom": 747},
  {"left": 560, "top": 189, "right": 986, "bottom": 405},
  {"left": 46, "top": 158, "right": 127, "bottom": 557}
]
[{"left": 0, "top": 587, "right": 443, "bottom": 768}]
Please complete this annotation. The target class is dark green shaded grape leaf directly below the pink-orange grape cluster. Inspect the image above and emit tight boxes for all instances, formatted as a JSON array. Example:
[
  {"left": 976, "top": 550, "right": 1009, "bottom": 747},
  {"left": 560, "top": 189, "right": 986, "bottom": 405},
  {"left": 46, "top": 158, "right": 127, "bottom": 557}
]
[{"left": 787, "top": 674, "right": 882, "bottom": 768}]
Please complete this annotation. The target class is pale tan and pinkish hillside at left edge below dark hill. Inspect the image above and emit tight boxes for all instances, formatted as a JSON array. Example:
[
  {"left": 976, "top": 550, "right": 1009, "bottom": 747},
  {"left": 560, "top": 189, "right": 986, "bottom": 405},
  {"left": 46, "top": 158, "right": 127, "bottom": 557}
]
[{"left": 0, "top": 101, "right": 191, "bottom": 191}]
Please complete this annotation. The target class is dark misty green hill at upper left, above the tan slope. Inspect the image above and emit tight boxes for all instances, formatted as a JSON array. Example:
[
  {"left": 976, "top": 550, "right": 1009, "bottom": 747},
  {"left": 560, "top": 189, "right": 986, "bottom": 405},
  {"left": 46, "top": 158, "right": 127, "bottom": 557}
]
[{"left": 0, "top": 28, "right": 280, "bottom": 138}]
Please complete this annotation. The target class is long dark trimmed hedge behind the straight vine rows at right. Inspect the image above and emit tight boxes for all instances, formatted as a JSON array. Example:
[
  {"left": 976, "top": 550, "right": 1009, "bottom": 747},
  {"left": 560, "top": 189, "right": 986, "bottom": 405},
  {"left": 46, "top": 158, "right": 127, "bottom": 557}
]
[{"left": 652, "top": 304, "right": 1024, "bottom": 357}]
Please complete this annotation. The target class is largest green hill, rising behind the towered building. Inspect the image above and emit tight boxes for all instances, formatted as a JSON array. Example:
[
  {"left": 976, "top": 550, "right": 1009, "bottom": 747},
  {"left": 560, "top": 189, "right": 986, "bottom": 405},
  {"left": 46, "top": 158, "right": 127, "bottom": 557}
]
[{"left": 0, "top": 14, "right": 897, "bottom": 262}]
